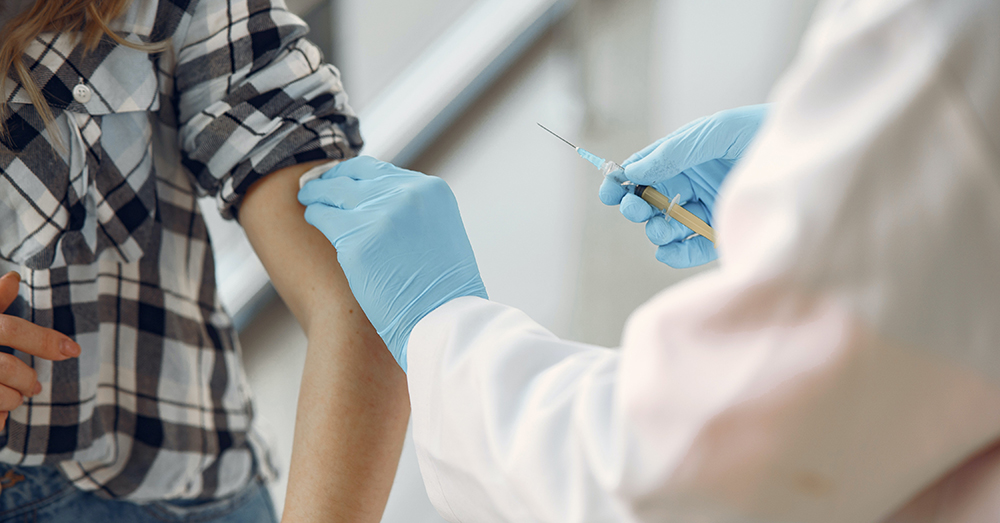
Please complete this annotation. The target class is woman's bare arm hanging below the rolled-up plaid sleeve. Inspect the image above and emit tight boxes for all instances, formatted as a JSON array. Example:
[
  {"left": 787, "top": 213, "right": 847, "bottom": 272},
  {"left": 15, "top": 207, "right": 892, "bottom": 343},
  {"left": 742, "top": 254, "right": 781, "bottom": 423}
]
[{"left": 240, "top": 165, "right": 409, "bottom": 522}]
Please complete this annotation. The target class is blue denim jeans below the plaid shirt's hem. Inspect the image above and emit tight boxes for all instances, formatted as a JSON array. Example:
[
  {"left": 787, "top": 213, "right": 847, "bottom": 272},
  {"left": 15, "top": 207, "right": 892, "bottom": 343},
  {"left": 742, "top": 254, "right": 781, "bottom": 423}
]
[{"left": 0, "top": 465, "right": 277, "bottom": 523}]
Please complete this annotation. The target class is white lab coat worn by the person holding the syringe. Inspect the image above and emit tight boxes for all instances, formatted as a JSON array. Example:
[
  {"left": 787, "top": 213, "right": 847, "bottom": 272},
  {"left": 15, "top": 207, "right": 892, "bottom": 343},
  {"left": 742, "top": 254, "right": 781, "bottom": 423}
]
[{"left": 408, "top": 0, "right": 1000, "bottom": 523}]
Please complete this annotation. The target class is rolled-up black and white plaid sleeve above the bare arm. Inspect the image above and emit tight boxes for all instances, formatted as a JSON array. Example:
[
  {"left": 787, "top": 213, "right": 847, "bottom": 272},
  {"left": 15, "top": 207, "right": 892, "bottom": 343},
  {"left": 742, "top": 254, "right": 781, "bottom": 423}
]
[{"left": 174, "top": 0, "right": 362, "bottom": 218}]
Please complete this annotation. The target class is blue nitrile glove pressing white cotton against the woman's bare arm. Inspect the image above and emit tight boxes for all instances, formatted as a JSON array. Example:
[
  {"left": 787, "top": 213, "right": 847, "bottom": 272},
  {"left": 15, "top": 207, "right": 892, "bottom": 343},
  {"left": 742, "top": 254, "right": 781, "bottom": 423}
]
[{"left": 299, "top": 156, "right": 488, "bottom": 372}]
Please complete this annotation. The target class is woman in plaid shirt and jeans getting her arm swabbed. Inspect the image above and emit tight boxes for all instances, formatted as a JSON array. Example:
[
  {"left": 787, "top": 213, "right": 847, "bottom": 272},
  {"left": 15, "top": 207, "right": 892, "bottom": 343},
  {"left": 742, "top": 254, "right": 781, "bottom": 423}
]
[{"left": 0, "top": 0, "right": 408, "bottom": 521}]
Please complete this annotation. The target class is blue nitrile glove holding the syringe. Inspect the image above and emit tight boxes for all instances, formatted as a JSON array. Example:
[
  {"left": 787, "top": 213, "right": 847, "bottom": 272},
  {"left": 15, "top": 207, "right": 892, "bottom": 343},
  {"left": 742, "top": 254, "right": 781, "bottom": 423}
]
[{"left": 600, "top": 105, "right": 769, "bottom": 269}]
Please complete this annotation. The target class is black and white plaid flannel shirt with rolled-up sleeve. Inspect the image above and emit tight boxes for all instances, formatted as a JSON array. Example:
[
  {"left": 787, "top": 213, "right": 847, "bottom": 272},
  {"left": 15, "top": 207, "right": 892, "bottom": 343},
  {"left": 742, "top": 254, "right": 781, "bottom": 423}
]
[{"left": 0, "top": 0, "right": 361, "bottom": 501}]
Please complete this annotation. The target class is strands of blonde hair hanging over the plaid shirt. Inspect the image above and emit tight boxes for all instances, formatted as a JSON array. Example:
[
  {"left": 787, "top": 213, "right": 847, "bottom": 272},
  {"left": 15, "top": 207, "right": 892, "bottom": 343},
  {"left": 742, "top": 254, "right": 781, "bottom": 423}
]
[{"left": 0, "top": 0, "right": 167, "bottom": 142}]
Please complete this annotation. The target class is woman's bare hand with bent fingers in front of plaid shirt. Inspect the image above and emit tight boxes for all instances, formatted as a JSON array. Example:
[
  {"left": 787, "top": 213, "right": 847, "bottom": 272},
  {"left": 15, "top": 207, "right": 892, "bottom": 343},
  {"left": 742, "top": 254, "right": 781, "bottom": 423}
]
[{"left": 0, "top": 272, "right": 80, "bottom": 428}]
